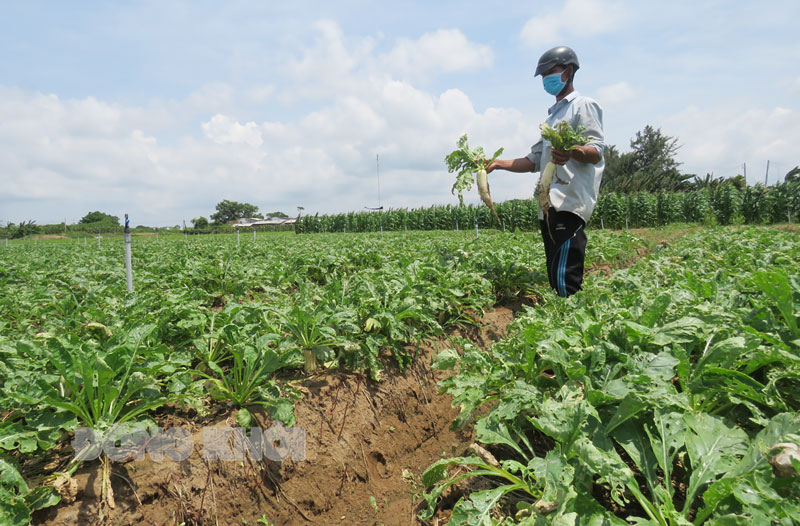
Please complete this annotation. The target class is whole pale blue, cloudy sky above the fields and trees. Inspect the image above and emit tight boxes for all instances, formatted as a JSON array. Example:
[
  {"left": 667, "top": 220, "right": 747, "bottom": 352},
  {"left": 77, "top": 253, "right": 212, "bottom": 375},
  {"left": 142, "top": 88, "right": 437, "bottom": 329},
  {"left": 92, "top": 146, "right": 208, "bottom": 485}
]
[{"left": 0, "top": 0, "right": 800, "bottom": 226}]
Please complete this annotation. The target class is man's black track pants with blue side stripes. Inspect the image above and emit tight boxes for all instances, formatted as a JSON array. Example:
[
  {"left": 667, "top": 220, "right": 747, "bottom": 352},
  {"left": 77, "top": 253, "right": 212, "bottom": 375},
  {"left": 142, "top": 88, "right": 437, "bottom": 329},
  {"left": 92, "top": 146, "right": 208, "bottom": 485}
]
[{"left": 539, "top": 212, "right": 586, "bottom": 298}]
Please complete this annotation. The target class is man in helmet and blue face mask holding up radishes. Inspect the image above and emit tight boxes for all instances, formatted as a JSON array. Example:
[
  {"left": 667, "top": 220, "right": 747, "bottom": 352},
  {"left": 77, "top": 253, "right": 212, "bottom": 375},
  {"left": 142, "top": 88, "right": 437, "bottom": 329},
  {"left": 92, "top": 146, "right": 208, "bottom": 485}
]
[{"left": 486, "top": 46, "right": 606, "bottom": 297}]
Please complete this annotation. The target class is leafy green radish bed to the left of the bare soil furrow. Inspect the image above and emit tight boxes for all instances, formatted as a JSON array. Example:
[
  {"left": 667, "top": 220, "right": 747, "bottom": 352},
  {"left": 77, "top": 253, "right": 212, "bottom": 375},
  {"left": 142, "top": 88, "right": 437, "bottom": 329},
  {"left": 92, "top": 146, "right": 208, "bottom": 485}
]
[{"left": 0, "top": 232, "right": 639, "bottom": 524}]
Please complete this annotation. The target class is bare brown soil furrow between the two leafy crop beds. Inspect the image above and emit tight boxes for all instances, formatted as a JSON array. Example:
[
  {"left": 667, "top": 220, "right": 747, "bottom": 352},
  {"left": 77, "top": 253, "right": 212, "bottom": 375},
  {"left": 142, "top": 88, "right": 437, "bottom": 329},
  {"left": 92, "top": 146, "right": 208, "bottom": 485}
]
[{"left": 33, "top": 308, "right": 520, "bottom": 526}]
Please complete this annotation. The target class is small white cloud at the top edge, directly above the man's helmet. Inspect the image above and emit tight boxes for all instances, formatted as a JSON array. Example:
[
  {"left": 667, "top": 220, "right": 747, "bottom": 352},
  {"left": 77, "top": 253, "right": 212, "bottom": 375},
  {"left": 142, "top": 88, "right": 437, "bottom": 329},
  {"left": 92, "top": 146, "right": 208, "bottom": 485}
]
[{"left": 520, "top": 0, "right": 627, "bottom": 48}]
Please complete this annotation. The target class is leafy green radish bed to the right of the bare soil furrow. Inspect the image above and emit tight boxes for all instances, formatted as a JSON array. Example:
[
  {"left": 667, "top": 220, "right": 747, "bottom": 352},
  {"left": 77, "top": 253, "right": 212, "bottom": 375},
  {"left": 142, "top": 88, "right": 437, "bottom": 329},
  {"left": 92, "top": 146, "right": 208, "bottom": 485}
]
[{"left": 423, "top": 228, "right": 800, "bottom": 526}]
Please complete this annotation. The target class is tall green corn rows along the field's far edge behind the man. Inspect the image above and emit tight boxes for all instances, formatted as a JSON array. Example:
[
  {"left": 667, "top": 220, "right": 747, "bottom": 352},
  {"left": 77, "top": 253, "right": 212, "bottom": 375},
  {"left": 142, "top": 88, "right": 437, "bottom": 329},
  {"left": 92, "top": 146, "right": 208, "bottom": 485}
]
[{"left": 295, "top": 181, "right": 800, "bottom": 234}]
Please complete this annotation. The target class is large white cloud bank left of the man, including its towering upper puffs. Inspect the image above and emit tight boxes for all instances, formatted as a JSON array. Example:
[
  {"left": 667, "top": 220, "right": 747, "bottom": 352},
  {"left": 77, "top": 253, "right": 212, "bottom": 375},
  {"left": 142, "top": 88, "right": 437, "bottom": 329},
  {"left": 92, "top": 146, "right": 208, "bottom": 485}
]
[{"left": 0, "top": 22, "right": 538, "bottom": 225}]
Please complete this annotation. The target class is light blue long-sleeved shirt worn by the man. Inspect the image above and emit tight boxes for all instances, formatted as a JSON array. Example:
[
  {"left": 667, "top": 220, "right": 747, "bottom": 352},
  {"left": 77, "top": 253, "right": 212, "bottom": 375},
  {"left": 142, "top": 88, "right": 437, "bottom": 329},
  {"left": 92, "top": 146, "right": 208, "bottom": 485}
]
[{"left": 526, "top": 91, "right": 607, "bottom": 223}]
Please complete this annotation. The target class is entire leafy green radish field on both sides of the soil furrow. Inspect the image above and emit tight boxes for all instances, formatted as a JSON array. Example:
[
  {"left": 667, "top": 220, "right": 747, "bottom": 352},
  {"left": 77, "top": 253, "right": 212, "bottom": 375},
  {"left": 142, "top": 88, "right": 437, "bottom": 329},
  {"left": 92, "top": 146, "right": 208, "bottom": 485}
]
[{"left": 0, "top": 226, "right": 800, "bottom": 526}]
